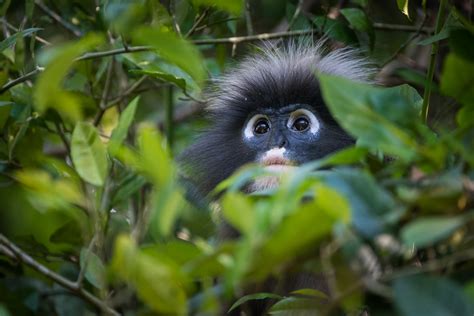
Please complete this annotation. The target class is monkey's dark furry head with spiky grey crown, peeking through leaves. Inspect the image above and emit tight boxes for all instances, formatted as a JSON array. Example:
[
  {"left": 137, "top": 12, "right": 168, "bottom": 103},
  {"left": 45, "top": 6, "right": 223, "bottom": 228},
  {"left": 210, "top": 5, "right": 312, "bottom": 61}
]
[{"left": 181, "top": 43, "right": 372, "bottom": 195}]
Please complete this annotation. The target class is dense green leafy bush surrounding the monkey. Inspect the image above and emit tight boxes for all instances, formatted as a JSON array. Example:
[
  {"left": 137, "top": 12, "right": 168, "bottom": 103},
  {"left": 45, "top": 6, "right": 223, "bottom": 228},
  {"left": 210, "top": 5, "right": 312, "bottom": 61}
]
[{"left": 0, "top": 0, "right": 474, "bottom": 315}]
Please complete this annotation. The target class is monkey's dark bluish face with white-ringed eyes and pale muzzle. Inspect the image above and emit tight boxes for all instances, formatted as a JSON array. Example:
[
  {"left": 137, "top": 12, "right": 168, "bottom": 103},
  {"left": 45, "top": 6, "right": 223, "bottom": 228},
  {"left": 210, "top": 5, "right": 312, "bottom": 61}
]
[{"left": 242, "top": 104, "right": 353, "bottom": 171}]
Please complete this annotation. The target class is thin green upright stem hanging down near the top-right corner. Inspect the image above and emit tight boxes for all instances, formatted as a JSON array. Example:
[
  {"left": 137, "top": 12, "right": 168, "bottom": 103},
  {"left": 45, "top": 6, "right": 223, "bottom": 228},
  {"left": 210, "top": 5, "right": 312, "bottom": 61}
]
[{"left": 421, "top": 0, "right": 447, "bottom": 123}]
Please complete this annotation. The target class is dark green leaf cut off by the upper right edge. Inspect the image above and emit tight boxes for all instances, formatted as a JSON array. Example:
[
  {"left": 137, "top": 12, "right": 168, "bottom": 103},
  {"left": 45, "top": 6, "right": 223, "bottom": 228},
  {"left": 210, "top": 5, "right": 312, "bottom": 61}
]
[{"left": 441, "top": 54, "right": 474, "bottom": 106}]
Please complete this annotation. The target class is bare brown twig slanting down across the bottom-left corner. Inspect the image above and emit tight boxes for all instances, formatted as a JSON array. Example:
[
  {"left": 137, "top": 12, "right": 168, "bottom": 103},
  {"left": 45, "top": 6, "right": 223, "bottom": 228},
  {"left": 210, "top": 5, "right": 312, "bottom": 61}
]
[{"left": 0, "top": 234, "right": 120, "bottom": 316}]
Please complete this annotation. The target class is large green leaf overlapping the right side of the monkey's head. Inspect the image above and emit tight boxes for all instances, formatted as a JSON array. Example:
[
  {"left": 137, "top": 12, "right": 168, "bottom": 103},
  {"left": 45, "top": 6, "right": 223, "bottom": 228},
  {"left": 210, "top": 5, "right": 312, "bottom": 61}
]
[{"left": 319, "top": 74, "right": 421, "bottom": 161}]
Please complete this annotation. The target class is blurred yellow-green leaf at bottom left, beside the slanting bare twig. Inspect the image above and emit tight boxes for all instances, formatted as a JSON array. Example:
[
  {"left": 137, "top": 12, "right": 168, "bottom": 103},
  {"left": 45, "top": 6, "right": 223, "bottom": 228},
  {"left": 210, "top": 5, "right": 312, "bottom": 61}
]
[{"left": 110, "top": 235, "right": 187, "bottom": 315}]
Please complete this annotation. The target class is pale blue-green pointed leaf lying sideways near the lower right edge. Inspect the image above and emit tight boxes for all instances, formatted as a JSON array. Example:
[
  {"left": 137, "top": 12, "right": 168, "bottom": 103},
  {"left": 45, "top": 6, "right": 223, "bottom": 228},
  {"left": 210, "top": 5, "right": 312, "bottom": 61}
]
[{"left": 400, "top": 216, "right": 465, "bottom": 248}]
